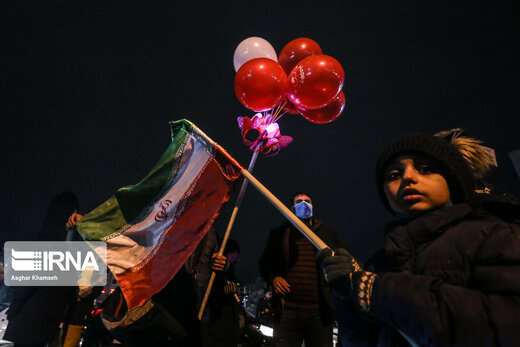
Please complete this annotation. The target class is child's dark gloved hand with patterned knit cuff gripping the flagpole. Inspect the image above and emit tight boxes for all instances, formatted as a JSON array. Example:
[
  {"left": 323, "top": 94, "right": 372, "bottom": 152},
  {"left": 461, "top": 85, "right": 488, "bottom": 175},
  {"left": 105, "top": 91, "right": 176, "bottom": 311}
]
[{"left": 316, "top": 248, "right": 377, "bottom": 313}]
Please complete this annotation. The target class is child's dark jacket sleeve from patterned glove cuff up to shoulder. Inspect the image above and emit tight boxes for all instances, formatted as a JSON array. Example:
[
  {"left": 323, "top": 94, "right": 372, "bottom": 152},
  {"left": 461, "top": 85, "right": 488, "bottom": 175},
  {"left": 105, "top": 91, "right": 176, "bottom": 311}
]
[{"left": 371, "top": 224, "right": 520, "bottom": 346}]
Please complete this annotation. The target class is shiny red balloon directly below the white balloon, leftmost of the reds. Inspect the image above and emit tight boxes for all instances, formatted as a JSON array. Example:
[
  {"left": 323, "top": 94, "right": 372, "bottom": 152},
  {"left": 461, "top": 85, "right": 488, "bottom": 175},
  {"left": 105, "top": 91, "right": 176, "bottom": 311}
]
[{"left": 235, "top": 58, "right": 288, "bottom": 112}]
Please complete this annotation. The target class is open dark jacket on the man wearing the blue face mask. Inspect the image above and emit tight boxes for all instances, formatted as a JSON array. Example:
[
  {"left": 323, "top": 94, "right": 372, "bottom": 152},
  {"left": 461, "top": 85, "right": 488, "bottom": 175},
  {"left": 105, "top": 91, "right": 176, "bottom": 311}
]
[{"left": 259, "top": 218, "right": 341, "bottom": 323}]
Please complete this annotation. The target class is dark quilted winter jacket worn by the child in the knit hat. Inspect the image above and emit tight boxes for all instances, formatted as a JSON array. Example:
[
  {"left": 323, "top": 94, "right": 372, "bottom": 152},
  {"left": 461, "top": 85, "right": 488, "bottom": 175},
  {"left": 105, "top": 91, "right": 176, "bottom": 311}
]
[{"left": 339, "top": 202, "right": 520, "bottom": 346}]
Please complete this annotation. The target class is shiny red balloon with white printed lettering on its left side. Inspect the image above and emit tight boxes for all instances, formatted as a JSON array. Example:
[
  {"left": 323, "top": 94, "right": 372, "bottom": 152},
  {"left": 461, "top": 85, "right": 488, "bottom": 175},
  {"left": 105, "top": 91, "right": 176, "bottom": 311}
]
[{"left": 287, "top": 54, "right": 345, "bottom": 110}]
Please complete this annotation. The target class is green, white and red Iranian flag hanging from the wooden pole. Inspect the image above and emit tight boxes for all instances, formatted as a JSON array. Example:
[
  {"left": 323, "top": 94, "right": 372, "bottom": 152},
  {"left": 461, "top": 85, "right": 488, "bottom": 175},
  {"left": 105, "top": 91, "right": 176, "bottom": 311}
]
[{"left": 77, "top": 120, "right": 243, "bottom": 309}]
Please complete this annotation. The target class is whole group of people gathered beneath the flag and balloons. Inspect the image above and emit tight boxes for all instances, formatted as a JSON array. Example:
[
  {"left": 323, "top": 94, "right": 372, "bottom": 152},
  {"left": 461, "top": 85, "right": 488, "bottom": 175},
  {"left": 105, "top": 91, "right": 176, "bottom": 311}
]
[{"left": 4, "top": 129, "right": 520, "bottom": 347}]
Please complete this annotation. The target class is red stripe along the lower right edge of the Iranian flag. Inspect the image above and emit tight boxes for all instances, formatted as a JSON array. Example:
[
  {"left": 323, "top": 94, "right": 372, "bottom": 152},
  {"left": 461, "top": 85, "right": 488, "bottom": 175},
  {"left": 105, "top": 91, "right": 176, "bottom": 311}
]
[{"left": 116, "top": 159, "right": 238, "bottom": 309}]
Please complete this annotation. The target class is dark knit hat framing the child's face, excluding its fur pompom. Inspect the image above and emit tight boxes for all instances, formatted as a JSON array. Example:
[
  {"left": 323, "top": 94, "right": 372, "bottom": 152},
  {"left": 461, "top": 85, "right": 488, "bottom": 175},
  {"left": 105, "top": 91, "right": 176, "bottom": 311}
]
[{"left": 376, "top": 134, "right": 474, "bottom": 211}]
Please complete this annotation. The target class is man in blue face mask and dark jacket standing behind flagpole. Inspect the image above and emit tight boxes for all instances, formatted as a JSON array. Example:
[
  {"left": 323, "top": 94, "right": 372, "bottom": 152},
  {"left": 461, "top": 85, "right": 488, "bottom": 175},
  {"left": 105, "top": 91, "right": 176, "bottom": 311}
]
[{"left": 260, "top": 192, "right": 341, "bottom": 347}]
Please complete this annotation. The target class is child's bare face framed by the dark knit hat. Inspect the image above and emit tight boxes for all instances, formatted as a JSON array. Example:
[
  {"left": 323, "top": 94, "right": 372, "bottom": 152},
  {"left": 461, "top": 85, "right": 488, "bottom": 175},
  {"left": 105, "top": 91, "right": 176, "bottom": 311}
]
[{"left": 384, "top": 155, "right": 450, "bottom": 215}]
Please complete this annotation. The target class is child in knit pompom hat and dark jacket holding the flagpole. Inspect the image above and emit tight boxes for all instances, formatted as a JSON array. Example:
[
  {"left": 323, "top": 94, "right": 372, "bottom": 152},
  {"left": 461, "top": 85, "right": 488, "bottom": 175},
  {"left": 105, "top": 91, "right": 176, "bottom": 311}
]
[{"left": 317, "top": 132, "right": 520, "bottom": 346}]
